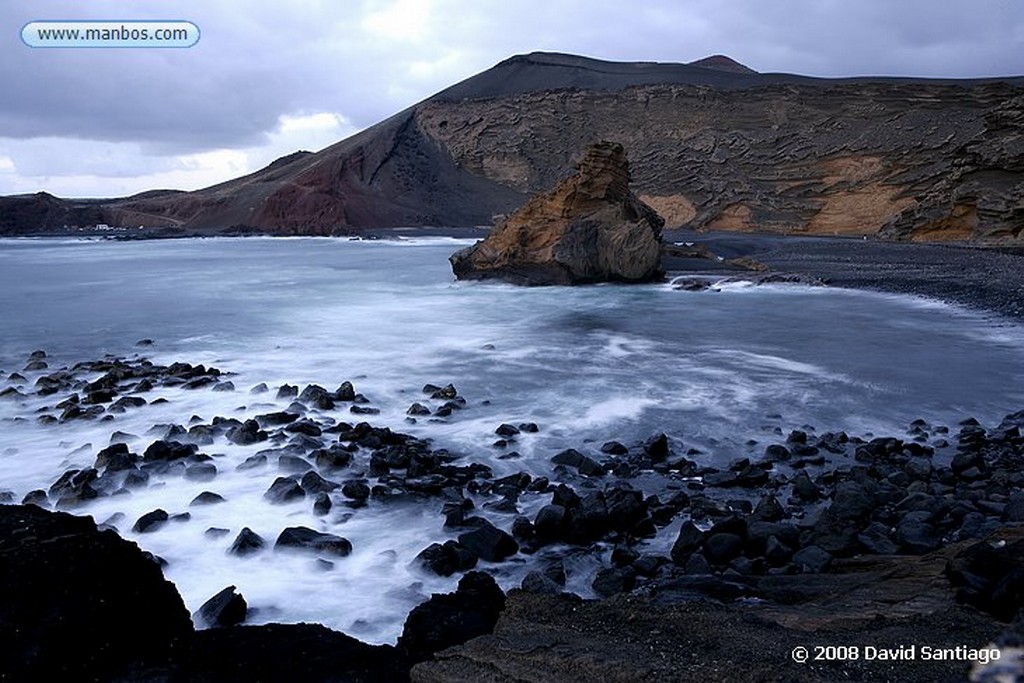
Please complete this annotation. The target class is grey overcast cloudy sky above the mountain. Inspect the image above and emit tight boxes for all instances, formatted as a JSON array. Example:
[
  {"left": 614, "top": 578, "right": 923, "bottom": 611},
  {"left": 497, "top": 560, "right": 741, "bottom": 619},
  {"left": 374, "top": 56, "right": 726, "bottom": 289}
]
[{"left": 0, "top": 0, "right": 1024, "bottom": 197}]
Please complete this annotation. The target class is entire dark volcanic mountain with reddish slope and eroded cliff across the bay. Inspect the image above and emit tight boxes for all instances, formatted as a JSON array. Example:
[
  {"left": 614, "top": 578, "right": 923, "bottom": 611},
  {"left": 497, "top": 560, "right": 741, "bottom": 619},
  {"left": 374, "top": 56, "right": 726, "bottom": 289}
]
[{"left": 0, "top": 52, "right": 1024, "bottom": 243}]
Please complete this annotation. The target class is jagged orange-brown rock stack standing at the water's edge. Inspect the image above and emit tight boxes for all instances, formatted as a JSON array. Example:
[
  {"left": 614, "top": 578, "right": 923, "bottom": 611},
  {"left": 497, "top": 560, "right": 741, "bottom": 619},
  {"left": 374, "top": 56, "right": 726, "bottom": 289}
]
[{"left": 451, "top": 141, "right": 665, "bottom": 285}]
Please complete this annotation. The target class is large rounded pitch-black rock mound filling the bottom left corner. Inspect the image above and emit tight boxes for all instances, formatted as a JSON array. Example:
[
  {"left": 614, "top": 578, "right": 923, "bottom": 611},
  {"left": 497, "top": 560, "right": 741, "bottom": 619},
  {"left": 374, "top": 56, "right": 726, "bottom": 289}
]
[{"left": 0, "top": 506, "right": 193, "bottom": 681}]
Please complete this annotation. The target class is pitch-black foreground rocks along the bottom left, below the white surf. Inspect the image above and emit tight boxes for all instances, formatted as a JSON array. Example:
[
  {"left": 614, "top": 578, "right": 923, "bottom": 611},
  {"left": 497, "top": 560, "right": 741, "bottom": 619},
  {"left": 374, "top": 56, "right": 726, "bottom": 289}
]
[{"left": 0, "top": 505, "right": 505, "bottom": 682}]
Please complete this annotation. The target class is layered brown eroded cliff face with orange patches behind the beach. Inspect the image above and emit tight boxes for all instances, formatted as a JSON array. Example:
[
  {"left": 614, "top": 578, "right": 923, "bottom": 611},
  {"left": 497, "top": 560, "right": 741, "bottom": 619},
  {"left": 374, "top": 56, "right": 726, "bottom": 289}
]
[{"left": 417, "top": 83, "right": 1024, "bottom": 241}]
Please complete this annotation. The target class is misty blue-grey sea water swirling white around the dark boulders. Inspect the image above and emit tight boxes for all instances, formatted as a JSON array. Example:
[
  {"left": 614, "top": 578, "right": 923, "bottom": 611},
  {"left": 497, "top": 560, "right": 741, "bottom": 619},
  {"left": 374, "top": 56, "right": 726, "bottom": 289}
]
[{"left": 0, "top": 238, "right": 1024, "bottom": 642}]
